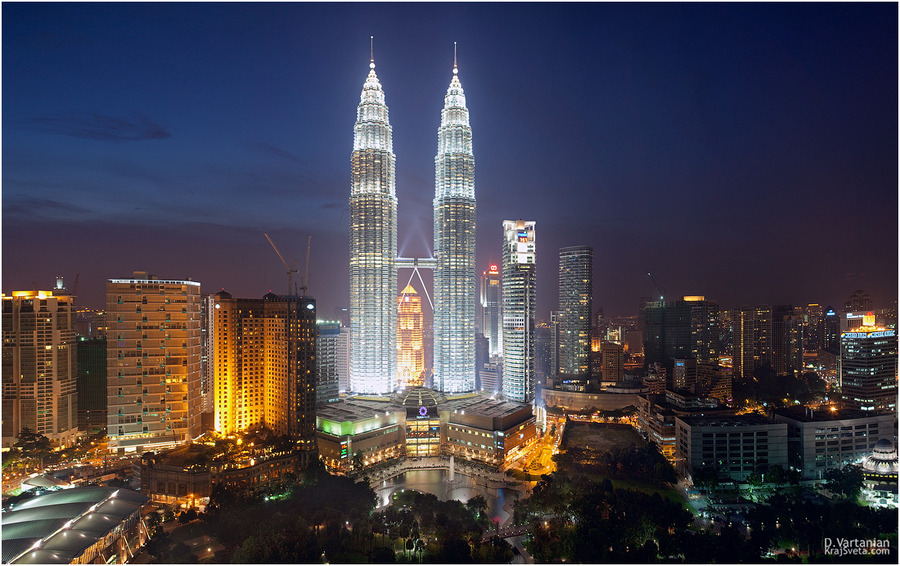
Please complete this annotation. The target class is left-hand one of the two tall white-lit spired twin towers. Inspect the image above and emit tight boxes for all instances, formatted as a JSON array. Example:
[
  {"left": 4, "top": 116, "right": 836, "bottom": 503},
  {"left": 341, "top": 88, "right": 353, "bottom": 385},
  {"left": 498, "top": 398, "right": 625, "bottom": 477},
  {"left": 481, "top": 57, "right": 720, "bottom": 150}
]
[{"left": 350, "top": 51, "right": 398, "bottom": 393}]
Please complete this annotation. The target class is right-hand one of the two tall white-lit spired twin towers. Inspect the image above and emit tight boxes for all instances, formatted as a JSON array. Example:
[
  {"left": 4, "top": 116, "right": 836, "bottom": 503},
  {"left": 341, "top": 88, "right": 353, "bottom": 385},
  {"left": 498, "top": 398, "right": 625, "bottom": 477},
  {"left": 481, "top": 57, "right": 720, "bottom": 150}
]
[{"left": 434, "top": 51, "right": 475, "bottom": 393}]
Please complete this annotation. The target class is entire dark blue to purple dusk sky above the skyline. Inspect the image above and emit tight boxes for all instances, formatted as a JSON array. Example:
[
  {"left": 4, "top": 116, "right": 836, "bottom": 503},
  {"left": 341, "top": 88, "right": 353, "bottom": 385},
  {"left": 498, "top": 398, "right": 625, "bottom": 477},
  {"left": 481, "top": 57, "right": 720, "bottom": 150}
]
[{"left": 2, "top": 3, "right": 898, "bottom": 318}]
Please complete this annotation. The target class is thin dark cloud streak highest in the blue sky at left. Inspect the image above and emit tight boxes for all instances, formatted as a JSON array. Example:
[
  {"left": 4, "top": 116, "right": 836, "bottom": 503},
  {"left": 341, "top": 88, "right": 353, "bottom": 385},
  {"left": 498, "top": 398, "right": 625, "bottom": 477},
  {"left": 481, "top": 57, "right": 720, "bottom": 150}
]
[{"left": 22, "top": 112, "right": 172, "bottom": 141}]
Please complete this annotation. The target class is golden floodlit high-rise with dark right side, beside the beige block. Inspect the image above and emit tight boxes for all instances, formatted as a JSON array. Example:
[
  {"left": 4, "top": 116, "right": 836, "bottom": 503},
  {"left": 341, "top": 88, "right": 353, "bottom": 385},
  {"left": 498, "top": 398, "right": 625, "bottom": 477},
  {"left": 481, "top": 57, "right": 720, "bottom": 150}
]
[{"left": 213, "top": 291, "right": 316, "bottom": 465}]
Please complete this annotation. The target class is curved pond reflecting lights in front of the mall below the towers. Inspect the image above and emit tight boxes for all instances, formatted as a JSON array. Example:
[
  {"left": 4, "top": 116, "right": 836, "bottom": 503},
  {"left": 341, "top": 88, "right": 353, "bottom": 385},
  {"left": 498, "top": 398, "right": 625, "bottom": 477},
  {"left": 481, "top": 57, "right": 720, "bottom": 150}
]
[{"left": 376, "top": 469, "right": 516, "bottom": 523}]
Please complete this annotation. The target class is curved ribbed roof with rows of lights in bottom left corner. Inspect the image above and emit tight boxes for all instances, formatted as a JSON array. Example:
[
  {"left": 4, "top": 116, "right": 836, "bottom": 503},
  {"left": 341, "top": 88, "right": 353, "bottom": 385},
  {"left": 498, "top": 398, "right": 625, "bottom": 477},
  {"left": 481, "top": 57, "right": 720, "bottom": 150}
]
[{"left": 2, "top": 487, "right": 149, "bottom": 564}]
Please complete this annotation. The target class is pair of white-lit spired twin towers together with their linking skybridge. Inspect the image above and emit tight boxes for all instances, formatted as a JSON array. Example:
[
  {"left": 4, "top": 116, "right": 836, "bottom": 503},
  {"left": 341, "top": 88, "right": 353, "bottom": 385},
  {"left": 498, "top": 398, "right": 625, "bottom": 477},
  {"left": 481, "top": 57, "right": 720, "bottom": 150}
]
[{"left": 350, "top": 42, "right": 476, "bottom": 394}]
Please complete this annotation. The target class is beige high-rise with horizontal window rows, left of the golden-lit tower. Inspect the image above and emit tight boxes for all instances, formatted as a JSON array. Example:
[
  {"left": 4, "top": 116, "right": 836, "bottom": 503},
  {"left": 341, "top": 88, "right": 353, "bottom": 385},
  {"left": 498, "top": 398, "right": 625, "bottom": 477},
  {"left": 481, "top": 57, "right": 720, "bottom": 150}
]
[{"left": 106, "top": 271, "right": 201, "bottom": 452}]
